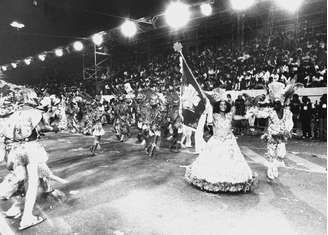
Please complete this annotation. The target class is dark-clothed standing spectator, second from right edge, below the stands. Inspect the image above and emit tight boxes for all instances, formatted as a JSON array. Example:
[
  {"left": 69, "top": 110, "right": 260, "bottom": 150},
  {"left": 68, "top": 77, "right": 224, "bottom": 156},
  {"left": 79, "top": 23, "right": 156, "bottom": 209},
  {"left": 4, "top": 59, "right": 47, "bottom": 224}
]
[{"left": 300, "top": 96, "right": 312, "bottom": 139}]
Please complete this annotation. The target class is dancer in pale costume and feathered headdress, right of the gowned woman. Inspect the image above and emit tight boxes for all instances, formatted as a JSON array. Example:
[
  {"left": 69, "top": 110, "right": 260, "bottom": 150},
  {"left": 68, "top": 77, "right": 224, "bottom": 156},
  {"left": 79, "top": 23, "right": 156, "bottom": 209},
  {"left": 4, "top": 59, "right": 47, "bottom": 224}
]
[{"left": 250, "top": 78, "right": 302, "bottom": 181}]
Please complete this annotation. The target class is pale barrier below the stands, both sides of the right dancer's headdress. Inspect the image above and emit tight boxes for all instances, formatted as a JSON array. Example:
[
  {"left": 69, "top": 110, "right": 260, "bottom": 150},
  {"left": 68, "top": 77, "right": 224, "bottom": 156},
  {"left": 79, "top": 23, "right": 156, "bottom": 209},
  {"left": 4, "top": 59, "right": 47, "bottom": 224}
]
[{"left": 227, "top": 87, "right": 327, "bottom": 103}]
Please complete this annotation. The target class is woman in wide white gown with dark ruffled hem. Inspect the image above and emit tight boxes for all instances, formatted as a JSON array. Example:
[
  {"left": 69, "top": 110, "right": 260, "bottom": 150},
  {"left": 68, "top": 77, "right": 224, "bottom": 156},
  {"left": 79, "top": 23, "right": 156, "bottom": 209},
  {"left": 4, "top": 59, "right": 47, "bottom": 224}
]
[{"left": 185, "top": 92, "right": 257, "bottom": 193}]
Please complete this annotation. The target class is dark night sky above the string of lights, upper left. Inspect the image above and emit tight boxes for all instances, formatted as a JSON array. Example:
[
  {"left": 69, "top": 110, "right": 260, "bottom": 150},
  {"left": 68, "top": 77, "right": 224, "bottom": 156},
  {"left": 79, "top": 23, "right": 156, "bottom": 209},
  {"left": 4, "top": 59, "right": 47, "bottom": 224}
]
[{"left": 0, "top": 0, "right": 195, "bottom": 64}]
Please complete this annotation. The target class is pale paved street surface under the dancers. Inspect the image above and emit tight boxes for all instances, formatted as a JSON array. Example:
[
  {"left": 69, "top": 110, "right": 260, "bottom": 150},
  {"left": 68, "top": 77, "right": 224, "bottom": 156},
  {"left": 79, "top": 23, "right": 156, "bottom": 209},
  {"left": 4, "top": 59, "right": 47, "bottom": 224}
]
[{"left": 0, "top": 129, "right": 327, "bottom": 235}]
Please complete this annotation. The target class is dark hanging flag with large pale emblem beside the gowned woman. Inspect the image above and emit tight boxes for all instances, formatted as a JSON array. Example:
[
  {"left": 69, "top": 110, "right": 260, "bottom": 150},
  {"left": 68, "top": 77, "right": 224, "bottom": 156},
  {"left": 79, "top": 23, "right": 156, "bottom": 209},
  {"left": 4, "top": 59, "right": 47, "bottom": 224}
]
[{"left": 180, "top": 57, "right": 206, "bottom": 129}]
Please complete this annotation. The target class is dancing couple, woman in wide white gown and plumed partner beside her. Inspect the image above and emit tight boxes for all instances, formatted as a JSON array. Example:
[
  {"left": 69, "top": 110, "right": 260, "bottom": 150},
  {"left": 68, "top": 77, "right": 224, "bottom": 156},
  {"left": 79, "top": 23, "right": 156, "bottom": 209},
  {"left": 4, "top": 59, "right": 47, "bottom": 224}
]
[{"left": 185, "top": 81, "right": 297, "bottom": 192}]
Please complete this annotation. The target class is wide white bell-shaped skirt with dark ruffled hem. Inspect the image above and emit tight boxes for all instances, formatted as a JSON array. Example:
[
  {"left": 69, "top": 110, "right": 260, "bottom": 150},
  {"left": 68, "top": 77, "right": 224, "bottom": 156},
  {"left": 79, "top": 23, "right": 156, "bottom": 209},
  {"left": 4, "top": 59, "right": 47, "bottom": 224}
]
[{"left": 185, "top": 134, "right": 257, "bottom": 192}]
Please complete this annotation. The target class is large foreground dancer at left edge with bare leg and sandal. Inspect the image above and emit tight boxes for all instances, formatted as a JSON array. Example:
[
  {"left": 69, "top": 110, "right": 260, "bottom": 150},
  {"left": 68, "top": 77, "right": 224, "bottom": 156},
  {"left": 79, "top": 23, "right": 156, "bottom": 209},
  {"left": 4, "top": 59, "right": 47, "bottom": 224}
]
[{"left": 0, "top": 107, "right": 67, "bottom": 230}]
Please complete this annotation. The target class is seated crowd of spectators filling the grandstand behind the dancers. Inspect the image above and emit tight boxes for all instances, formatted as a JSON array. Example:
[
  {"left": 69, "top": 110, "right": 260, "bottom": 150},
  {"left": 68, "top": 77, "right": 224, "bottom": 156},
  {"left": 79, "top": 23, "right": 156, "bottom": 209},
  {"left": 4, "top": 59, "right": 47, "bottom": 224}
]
[{"left": 104, "top": 30, "right": 327, "bottom": 93}]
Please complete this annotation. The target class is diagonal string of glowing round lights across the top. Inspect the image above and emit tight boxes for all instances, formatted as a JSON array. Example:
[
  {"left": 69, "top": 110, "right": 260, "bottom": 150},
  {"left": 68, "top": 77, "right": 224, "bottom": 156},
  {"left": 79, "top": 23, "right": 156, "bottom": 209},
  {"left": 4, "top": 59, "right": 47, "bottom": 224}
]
[{"left": 0, "top": 0, "right": 303, "bottom": 72}]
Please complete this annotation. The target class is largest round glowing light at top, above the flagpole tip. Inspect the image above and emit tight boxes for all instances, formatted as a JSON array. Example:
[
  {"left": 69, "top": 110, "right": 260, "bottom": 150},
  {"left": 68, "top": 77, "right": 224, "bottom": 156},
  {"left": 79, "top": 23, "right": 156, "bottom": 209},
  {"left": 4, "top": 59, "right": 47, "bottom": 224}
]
[{"left": 164, "top": 2, "right": 190, "bottom": 29}]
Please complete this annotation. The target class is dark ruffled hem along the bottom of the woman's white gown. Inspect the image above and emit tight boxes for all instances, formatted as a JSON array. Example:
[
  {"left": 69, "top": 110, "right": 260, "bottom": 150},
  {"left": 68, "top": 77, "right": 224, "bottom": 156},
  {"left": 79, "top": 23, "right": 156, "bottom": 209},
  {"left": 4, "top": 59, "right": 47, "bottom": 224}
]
[{"left": 185, "top": 172, "right": 257, "bottom": 193}]
